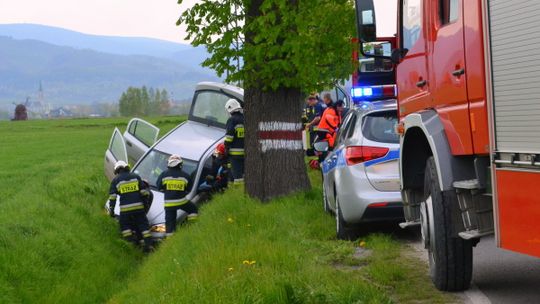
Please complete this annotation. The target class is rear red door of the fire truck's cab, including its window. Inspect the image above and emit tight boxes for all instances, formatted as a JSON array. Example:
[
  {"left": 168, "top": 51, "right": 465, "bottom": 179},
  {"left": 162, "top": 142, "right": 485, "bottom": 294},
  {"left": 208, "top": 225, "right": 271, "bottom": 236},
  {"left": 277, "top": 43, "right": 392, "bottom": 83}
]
[{"left": 426, "top": 0, "right": 473, "bottom": 155}]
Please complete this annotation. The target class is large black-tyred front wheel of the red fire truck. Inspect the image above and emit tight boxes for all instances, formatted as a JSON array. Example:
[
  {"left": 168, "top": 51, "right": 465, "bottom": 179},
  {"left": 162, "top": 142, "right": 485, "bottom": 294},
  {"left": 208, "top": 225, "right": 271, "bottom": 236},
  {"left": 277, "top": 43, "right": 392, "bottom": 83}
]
[{"left": 420, "top": 157, "right": 472, "bottom": 291}]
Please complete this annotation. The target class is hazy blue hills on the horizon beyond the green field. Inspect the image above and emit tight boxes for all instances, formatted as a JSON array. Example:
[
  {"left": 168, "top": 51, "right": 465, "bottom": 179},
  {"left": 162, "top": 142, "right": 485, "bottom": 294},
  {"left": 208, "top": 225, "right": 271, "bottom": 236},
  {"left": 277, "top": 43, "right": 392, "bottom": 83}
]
[{"left": 0, "top": 36, "right": 218, "bottom": 104}]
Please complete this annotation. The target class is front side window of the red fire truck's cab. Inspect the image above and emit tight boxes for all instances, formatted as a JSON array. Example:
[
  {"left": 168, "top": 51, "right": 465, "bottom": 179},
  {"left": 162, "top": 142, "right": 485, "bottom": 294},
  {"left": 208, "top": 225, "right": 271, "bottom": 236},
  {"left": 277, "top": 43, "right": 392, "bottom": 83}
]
[{"left": 402, "top": 0, "right": 422, "bottom": 50}]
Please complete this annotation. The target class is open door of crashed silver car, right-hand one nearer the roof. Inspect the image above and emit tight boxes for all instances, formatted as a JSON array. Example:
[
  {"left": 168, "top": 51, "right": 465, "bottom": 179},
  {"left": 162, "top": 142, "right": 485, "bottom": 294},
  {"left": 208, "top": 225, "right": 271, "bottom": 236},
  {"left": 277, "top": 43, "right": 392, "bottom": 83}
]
[{"left": 124, "top": 118, "right": 159, "bottom": 165}]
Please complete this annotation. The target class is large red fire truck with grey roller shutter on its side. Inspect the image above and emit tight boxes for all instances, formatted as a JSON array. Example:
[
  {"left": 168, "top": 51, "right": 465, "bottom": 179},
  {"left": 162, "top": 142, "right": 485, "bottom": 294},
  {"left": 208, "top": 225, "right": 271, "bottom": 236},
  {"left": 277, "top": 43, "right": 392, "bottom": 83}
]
[{"left": 356, "top": 0, "right": 540, "bottom": 291}]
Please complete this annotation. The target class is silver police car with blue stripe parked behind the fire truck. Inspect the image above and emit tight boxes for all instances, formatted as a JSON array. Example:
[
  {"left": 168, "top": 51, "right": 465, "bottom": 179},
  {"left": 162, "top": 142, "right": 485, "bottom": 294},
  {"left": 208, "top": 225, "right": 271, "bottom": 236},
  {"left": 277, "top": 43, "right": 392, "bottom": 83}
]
[{"left": 321, "top": 100, "right": 403, "bottom": 239}]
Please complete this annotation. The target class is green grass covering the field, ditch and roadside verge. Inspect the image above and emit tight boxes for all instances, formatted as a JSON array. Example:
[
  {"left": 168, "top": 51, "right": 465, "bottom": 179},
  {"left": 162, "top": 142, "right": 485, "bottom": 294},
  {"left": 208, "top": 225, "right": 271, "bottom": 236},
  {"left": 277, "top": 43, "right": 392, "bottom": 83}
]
[{"left": 0, "top": 118, "right": 455, "bottom": 303}]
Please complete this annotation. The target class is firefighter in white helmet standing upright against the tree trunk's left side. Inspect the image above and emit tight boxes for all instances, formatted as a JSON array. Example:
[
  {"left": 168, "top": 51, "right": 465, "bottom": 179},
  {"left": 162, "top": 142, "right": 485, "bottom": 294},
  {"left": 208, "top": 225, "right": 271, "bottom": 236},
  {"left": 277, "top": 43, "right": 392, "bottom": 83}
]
[{"left": 225, "top": 99, "right": 244, "bottom": 184}]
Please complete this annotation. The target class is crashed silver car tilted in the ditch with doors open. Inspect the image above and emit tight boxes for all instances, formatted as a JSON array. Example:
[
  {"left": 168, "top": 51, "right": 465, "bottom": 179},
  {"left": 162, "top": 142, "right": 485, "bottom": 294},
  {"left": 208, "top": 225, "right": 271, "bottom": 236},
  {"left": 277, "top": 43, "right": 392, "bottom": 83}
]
[{"left": 104, "top": 82, "right": 244, "bottom": 237}]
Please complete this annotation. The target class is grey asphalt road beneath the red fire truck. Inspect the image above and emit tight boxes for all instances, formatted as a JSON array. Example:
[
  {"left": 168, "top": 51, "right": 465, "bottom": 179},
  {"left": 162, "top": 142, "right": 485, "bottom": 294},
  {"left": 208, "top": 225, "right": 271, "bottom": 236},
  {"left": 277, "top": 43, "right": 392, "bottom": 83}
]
[{"left": 473, "top": 237, "right": 540, "bottom": 304}]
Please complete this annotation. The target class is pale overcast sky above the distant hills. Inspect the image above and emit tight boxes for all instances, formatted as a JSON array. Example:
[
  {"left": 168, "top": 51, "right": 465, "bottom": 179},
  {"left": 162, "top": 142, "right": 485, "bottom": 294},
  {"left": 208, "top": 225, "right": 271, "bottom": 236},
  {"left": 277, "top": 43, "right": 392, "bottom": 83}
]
[{"left": 0, "top": 0, "right": 396, "bottom": 43}]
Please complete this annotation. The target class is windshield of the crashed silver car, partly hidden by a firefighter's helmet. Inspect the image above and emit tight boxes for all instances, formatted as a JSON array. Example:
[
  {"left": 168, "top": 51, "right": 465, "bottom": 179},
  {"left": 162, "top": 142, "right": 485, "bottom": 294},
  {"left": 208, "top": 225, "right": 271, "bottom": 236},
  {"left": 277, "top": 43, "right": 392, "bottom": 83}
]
[{"left": 133, "top": 149, "right": 198, "bottom": 188}]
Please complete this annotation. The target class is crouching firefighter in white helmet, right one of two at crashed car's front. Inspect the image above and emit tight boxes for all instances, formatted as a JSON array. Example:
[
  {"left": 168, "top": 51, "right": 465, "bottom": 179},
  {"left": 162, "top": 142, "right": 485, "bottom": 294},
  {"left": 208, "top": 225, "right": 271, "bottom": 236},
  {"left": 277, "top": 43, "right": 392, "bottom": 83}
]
[{"left": 156, "top": 154, "right": 199, "bottom": 236}]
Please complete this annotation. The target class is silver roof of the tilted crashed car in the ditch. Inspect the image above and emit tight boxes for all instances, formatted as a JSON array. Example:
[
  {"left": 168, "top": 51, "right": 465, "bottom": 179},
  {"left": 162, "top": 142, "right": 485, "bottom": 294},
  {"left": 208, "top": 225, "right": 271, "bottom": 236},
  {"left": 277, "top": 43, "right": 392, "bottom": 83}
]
[{"left": 154, "top": 120, "right": 225, "bottom": 161}]
